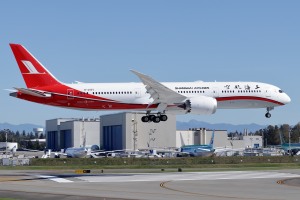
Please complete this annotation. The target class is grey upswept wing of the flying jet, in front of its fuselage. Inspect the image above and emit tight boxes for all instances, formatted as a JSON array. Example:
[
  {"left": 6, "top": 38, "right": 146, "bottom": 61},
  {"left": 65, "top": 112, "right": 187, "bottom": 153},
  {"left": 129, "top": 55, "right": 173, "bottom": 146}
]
[{"left": 130, "top": 70, "right": 186, "bottom": 111}]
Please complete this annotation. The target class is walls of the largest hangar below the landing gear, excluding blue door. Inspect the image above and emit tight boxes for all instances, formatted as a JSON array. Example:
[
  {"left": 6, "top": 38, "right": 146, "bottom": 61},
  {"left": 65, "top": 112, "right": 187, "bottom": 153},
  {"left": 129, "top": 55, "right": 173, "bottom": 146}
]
[{"left": 100, "top": 113, "right": 176, "bottom": 149}]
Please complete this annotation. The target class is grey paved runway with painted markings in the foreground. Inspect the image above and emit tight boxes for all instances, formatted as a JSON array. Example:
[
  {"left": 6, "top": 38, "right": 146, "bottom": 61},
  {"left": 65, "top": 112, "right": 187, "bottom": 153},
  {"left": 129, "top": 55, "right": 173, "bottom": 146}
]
[{"left": 0, "top": 170, "right": 300, "bottom": 200}]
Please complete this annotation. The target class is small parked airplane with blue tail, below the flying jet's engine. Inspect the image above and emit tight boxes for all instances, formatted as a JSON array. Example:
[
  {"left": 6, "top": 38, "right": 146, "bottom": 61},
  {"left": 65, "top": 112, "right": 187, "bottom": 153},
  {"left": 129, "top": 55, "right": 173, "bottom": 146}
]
[{"left": 180, "top": 131, "right": 215, "bottom": 157}]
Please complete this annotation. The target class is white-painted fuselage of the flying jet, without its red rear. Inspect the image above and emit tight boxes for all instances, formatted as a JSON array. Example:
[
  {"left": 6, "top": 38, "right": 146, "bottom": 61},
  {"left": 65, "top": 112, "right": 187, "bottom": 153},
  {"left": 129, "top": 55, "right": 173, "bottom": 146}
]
[{"left": 66, "top": 82, "right": 290, "bottom": 112}]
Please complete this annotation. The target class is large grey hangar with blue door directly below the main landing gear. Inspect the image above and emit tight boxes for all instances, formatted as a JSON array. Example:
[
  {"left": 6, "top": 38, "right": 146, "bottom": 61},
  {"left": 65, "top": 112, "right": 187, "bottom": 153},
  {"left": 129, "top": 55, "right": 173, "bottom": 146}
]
[{"left": 100, "top": 113, "right": 176, "bottom": 150}]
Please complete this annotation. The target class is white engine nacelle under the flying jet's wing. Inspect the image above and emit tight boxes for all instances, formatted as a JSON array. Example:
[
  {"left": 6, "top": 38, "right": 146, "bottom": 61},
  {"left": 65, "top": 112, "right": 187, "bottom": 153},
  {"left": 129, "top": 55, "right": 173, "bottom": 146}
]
[{"left": 184, "top": 96, "right": 217, "bottom": 115}]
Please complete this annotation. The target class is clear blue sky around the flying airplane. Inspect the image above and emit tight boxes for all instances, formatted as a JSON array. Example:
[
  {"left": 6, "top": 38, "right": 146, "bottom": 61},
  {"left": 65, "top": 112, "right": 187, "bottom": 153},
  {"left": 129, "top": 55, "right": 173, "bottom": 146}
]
[{"left": 0, "top": 0, "right": 300, "bottom": 126}]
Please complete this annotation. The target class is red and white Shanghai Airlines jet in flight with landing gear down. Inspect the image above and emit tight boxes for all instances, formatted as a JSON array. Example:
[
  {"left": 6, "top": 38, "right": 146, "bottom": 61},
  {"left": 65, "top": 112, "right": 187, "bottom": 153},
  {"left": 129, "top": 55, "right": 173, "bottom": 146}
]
[{"left": 10, "top": 44, "right": 291, "bottom": 123}]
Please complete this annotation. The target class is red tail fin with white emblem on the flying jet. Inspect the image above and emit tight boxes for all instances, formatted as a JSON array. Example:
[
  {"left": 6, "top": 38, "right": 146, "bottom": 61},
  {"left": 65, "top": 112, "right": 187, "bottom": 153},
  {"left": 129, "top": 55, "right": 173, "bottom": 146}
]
[{"left": 10, "top": 44, "right": 61, "bottom": 88}]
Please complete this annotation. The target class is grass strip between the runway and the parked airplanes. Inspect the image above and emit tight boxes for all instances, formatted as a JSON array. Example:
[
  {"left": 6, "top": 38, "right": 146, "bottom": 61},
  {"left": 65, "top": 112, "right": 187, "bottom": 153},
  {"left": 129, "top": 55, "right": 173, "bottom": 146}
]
[{"left": 0, "top": 156, "right": 300, "bottom": 172}]
